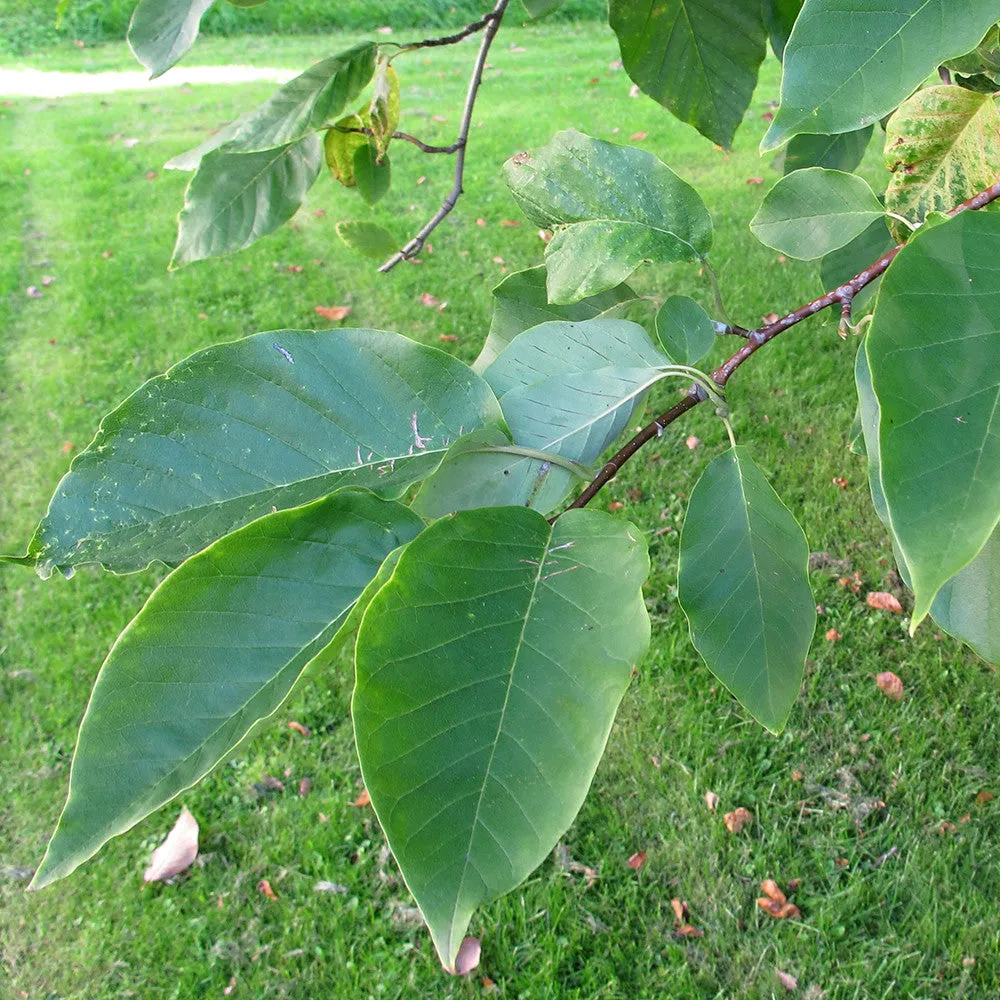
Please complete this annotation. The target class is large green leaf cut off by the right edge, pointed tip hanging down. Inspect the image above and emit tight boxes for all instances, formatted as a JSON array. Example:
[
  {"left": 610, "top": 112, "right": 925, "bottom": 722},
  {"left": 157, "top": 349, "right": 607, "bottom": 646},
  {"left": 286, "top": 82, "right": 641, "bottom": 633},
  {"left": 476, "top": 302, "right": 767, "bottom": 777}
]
[{"left": 865, "top": 212, "right": 1000, "bottom": 630}]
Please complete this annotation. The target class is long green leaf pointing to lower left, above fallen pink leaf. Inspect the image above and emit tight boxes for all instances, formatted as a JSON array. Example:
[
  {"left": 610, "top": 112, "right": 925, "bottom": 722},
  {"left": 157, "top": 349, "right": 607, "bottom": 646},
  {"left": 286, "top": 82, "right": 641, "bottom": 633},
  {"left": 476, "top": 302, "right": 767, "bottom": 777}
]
[{"left": 32, "top": 491, "right": 423, "bottom": 889}]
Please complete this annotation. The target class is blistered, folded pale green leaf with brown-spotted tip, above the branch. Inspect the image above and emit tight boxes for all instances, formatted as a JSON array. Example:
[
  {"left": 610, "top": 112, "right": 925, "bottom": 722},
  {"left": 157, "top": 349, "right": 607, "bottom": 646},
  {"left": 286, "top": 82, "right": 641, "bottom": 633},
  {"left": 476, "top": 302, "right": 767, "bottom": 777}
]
[{"left": 504, "top": 130, "right": 712, "bottom": 305}]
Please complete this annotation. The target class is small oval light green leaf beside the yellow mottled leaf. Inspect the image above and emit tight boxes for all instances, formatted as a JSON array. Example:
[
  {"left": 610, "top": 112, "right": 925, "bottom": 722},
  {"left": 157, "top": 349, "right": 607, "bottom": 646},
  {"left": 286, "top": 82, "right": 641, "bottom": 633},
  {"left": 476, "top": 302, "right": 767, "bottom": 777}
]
[{"left": 750, "top": 167, "right": 885, "bottom": 260}]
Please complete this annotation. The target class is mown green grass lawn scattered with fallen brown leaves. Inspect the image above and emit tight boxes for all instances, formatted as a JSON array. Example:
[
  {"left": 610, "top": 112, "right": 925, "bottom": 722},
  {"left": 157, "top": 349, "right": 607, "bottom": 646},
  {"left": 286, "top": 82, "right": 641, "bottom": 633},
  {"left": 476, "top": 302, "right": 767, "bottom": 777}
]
[{"left": 0, "top": 25, "right": 1000, "bottom": 1000}]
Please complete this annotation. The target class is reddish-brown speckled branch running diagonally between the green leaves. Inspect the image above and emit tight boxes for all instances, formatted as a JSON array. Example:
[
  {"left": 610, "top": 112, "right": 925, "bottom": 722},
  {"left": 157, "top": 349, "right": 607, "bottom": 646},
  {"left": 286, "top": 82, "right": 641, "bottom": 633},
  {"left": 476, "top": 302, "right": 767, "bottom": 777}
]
[{"left": 564, "top": 180, "right": 1000, "bottom": 520}]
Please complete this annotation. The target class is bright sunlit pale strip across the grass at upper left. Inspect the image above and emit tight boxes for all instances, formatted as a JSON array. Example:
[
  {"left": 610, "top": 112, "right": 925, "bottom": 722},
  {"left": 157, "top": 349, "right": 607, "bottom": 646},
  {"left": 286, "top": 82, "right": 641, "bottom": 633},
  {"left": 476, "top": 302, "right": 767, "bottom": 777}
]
[{"left": 0, "top": 66, "right": 297, "bottom": 97}]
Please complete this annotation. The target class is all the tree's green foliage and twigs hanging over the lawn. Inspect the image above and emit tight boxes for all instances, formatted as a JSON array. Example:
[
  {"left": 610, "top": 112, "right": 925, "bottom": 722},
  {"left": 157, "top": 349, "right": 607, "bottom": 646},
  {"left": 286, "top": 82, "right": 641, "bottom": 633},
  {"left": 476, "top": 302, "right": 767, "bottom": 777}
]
[{"left": 6, "top": 0, "right": 1000, "bottom": 970}]
